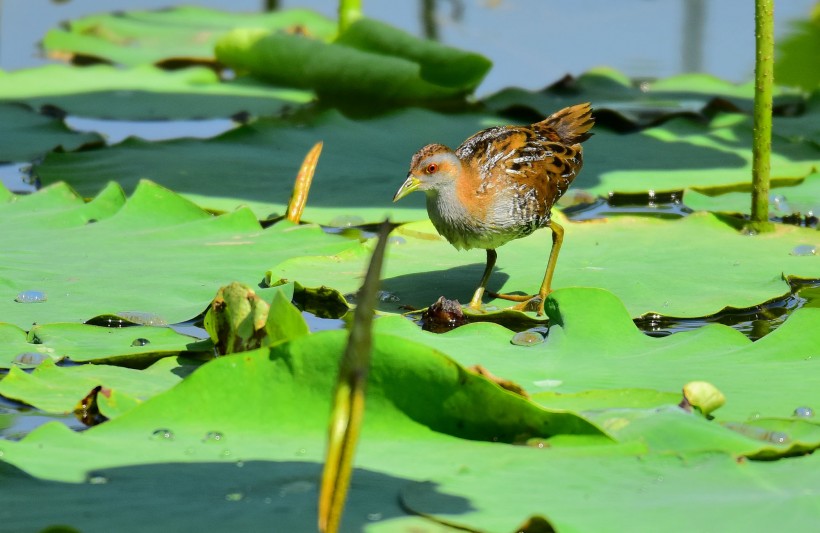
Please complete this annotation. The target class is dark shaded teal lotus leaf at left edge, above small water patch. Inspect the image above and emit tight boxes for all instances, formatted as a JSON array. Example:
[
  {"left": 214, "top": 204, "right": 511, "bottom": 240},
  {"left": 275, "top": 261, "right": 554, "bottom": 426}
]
[{"left": 0, "top": 103, "right": 103, "bottom": 162}]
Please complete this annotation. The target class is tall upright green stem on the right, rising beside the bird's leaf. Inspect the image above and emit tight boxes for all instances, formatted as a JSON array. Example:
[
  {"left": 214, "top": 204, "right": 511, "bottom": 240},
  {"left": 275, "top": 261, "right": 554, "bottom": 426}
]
[{"left": 746, "top": 0, "right": 774, "bottom": 233}]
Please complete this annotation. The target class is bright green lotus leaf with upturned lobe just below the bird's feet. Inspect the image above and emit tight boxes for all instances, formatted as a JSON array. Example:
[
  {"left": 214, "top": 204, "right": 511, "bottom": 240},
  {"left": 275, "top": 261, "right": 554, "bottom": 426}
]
[{"left": 375, "top": 288, "right": 820, "bottom": 421}]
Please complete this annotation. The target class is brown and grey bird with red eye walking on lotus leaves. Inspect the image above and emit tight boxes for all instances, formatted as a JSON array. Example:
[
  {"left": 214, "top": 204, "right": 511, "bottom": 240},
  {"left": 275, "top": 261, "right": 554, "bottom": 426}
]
[{"left": 393, "top": 102, "right": 595, "bottom": 316}]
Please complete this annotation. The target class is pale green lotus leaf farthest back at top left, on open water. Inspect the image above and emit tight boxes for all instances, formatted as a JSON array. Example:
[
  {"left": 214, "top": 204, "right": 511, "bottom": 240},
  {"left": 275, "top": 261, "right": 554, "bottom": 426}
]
[{"left": 43, "top": 7, "right": 336, "bottom": 66}]
